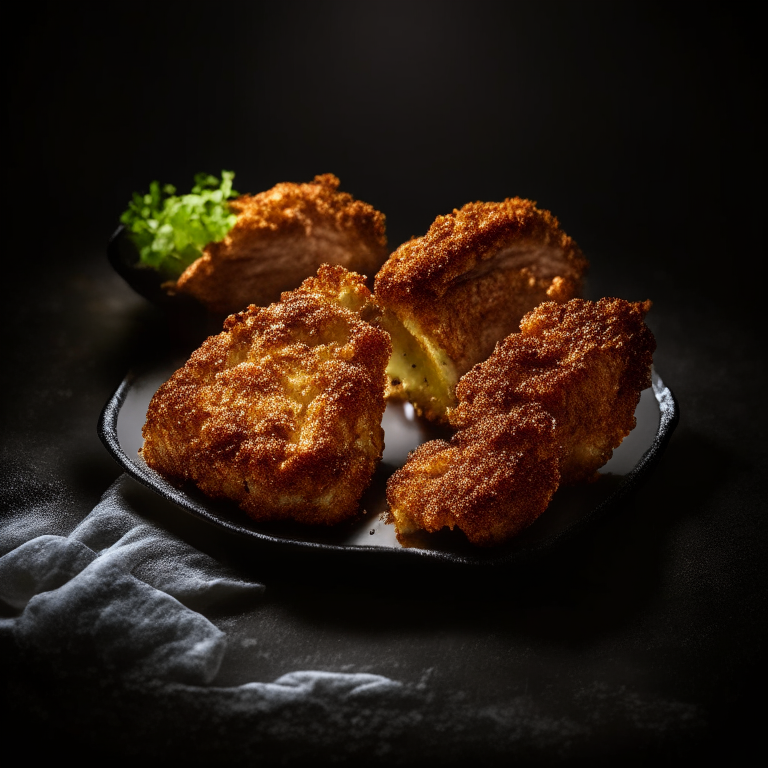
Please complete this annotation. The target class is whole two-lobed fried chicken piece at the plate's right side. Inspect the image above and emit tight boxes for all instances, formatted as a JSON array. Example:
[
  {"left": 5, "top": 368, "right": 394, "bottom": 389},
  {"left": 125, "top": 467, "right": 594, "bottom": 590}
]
[{"left": 387, "top": 299, "right": 656, "bottom": 545}]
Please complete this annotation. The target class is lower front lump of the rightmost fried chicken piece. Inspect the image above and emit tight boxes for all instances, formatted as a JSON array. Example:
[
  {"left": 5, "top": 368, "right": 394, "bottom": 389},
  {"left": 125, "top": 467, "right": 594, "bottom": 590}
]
[{"left": 387, "top": 404, "right": 560, "bottom": 546}]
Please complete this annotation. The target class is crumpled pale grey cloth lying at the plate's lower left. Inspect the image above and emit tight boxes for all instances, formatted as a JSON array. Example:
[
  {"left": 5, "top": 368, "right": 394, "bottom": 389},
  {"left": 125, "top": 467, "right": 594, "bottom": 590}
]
[{"left": 0, "top": 476, "right": 398, "bottom": 706}]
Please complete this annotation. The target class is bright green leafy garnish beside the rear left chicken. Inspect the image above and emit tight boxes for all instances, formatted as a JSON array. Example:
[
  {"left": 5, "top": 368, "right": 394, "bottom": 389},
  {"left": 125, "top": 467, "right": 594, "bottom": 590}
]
[{"left": 120, "top": 171, "right": 238, "bottom": 278}]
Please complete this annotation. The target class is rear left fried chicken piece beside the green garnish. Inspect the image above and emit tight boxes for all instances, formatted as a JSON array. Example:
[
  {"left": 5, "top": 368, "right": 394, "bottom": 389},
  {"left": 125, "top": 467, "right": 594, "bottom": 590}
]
[{"left": 173, "top": 173, "right": 387, "bottom": 313}]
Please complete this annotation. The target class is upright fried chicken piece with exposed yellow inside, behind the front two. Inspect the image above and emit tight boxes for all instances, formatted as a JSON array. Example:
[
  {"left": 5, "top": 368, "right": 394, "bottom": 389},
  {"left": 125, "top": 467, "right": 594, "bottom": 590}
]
[{"left": 375, "top": 197, "right": 587, "bottom": 421}]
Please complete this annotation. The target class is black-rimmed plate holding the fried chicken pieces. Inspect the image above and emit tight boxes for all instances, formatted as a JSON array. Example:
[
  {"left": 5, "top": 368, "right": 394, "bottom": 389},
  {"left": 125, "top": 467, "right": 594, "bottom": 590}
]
[{"left": 98, "top": 361, "right": 679, "bottom": 565}]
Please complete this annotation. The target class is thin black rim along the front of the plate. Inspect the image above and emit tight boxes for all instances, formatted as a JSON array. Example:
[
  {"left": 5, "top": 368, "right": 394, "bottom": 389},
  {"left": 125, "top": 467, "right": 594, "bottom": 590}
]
[{"left": 97, "top": 367, "right": 680, "bottom": 567}]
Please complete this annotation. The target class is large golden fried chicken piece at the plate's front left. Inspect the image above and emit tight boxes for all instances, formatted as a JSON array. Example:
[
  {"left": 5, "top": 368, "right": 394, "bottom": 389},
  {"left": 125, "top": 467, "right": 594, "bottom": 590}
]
[{"left": 141, "top": 266, "right": 391, "bottom": 524}]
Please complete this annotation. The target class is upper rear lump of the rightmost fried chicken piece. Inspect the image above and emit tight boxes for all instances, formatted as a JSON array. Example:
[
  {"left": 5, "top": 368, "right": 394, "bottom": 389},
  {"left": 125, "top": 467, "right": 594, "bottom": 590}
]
[{"left": 450, "top": 298, "right": 656, "bottom": 483}]
